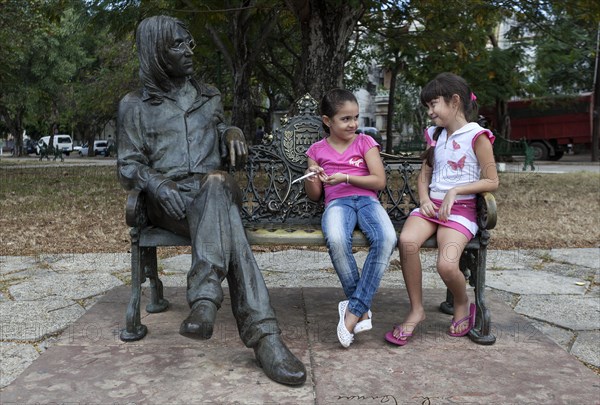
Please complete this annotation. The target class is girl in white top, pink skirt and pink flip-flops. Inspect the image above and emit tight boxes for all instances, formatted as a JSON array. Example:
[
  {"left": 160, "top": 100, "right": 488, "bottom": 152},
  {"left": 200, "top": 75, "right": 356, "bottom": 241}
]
[{"left": 385, "top": 73, "right": 498, "bottom": 346}]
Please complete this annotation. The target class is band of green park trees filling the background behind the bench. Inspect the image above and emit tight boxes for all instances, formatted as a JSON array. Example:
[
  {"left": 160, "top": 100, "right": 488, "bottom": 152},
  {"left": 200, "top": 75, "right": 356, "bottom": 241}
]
[{"left": 0, "top": 0, "right": 600, "bottom": 160}]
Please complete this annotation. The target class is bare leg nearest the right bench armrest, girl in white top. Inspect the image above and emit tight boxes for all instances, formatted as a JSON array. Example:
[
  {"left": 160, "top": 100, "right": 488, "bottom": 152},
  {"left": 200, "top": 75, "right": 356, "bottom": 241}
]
[{"left": 437, "top": 226, "right": 469, "bottom": 333}]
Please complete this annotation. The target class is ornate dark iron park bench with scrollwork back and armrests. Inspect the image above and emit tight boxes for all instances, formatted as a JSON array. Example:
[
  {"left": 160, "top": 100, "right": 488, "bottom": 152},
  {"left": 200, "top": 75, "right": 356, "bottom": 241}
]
[{"left": 120, "top": 94, "right": 496, "bottom": 345}]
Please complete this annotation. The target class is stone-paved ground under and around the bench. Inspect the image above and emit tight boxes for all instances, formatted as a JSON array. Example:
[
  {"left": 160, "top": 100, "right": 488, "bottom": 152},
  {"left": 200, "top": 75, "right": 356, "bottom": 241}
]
[{"left": 0, "top": 248, "right": 600, "bottom": 404}]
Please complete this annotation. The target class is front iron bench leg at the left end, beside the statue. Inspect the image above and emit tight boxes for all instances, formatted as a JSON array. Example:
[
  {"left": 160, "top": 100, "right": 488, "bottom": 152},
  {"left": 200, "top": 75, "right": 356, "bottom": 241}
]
[{"left": 119, "top": 234, "right": 148, "bottom": 342}]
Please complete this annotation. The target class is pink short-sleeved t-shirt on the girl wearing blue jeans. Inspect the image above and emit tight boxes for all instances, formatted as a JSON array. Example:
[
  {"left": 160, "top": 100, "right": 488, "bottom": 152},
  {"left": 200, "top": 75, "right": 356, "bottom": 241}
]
[{"left": 306, "top": 134, "right": 379, "bottom": 205}]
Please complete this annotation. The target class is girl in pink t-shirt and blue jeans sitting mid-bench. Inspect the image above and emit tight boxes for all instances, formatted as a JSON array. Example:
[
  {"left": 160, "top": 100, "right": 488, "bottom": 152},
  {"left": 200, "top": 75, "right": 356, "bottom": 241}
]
[{"left": 305, "top": 89, "right": 397, "bottom": 347}]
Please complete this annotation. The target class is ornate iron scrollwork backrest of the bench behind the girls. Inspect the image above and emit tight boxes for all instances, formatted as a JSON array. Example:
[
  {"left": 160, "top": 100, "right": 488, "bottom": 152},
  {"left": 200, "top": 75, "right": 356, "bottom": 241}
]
[{"left": 234, "top": 94, "right": 419, "bottom": 225}]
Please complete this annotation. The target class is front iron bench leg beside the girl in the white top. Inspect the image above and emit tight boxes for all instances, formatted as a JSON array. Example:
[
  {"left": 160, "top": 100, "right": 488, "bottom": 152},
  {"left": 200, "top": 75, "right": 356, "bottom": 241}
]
[{"left": 469, "top": 246, "right": 496, "bottom": 345}]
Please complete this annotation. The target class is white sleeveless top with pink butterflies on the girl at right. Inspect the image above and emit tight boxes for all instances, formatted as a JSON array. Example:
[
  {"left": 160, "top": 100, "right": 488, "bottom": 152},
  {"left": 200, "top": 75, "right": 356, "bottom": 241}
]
[{"left": 425, "top": 122, "right": 495, "bottom": 199}]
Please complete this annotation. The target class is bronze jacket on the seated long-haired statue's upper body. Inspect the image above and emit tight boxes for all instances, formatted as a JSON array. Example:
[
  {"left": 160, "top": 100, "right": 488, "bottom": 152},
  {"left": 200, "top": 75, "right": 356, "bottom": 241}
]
[{"left": 117, "top": 80, "right": 228, "bottom": 194}]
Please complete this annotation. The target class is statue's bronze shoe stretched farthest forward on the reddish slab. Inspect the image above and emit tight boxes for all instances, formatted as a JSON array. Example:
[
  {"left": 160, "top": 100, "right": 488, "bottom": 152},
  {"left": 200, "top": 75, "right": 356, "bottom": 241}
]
[{"left": 254, "top": 335, "right": 306, "bottom": 385}]
